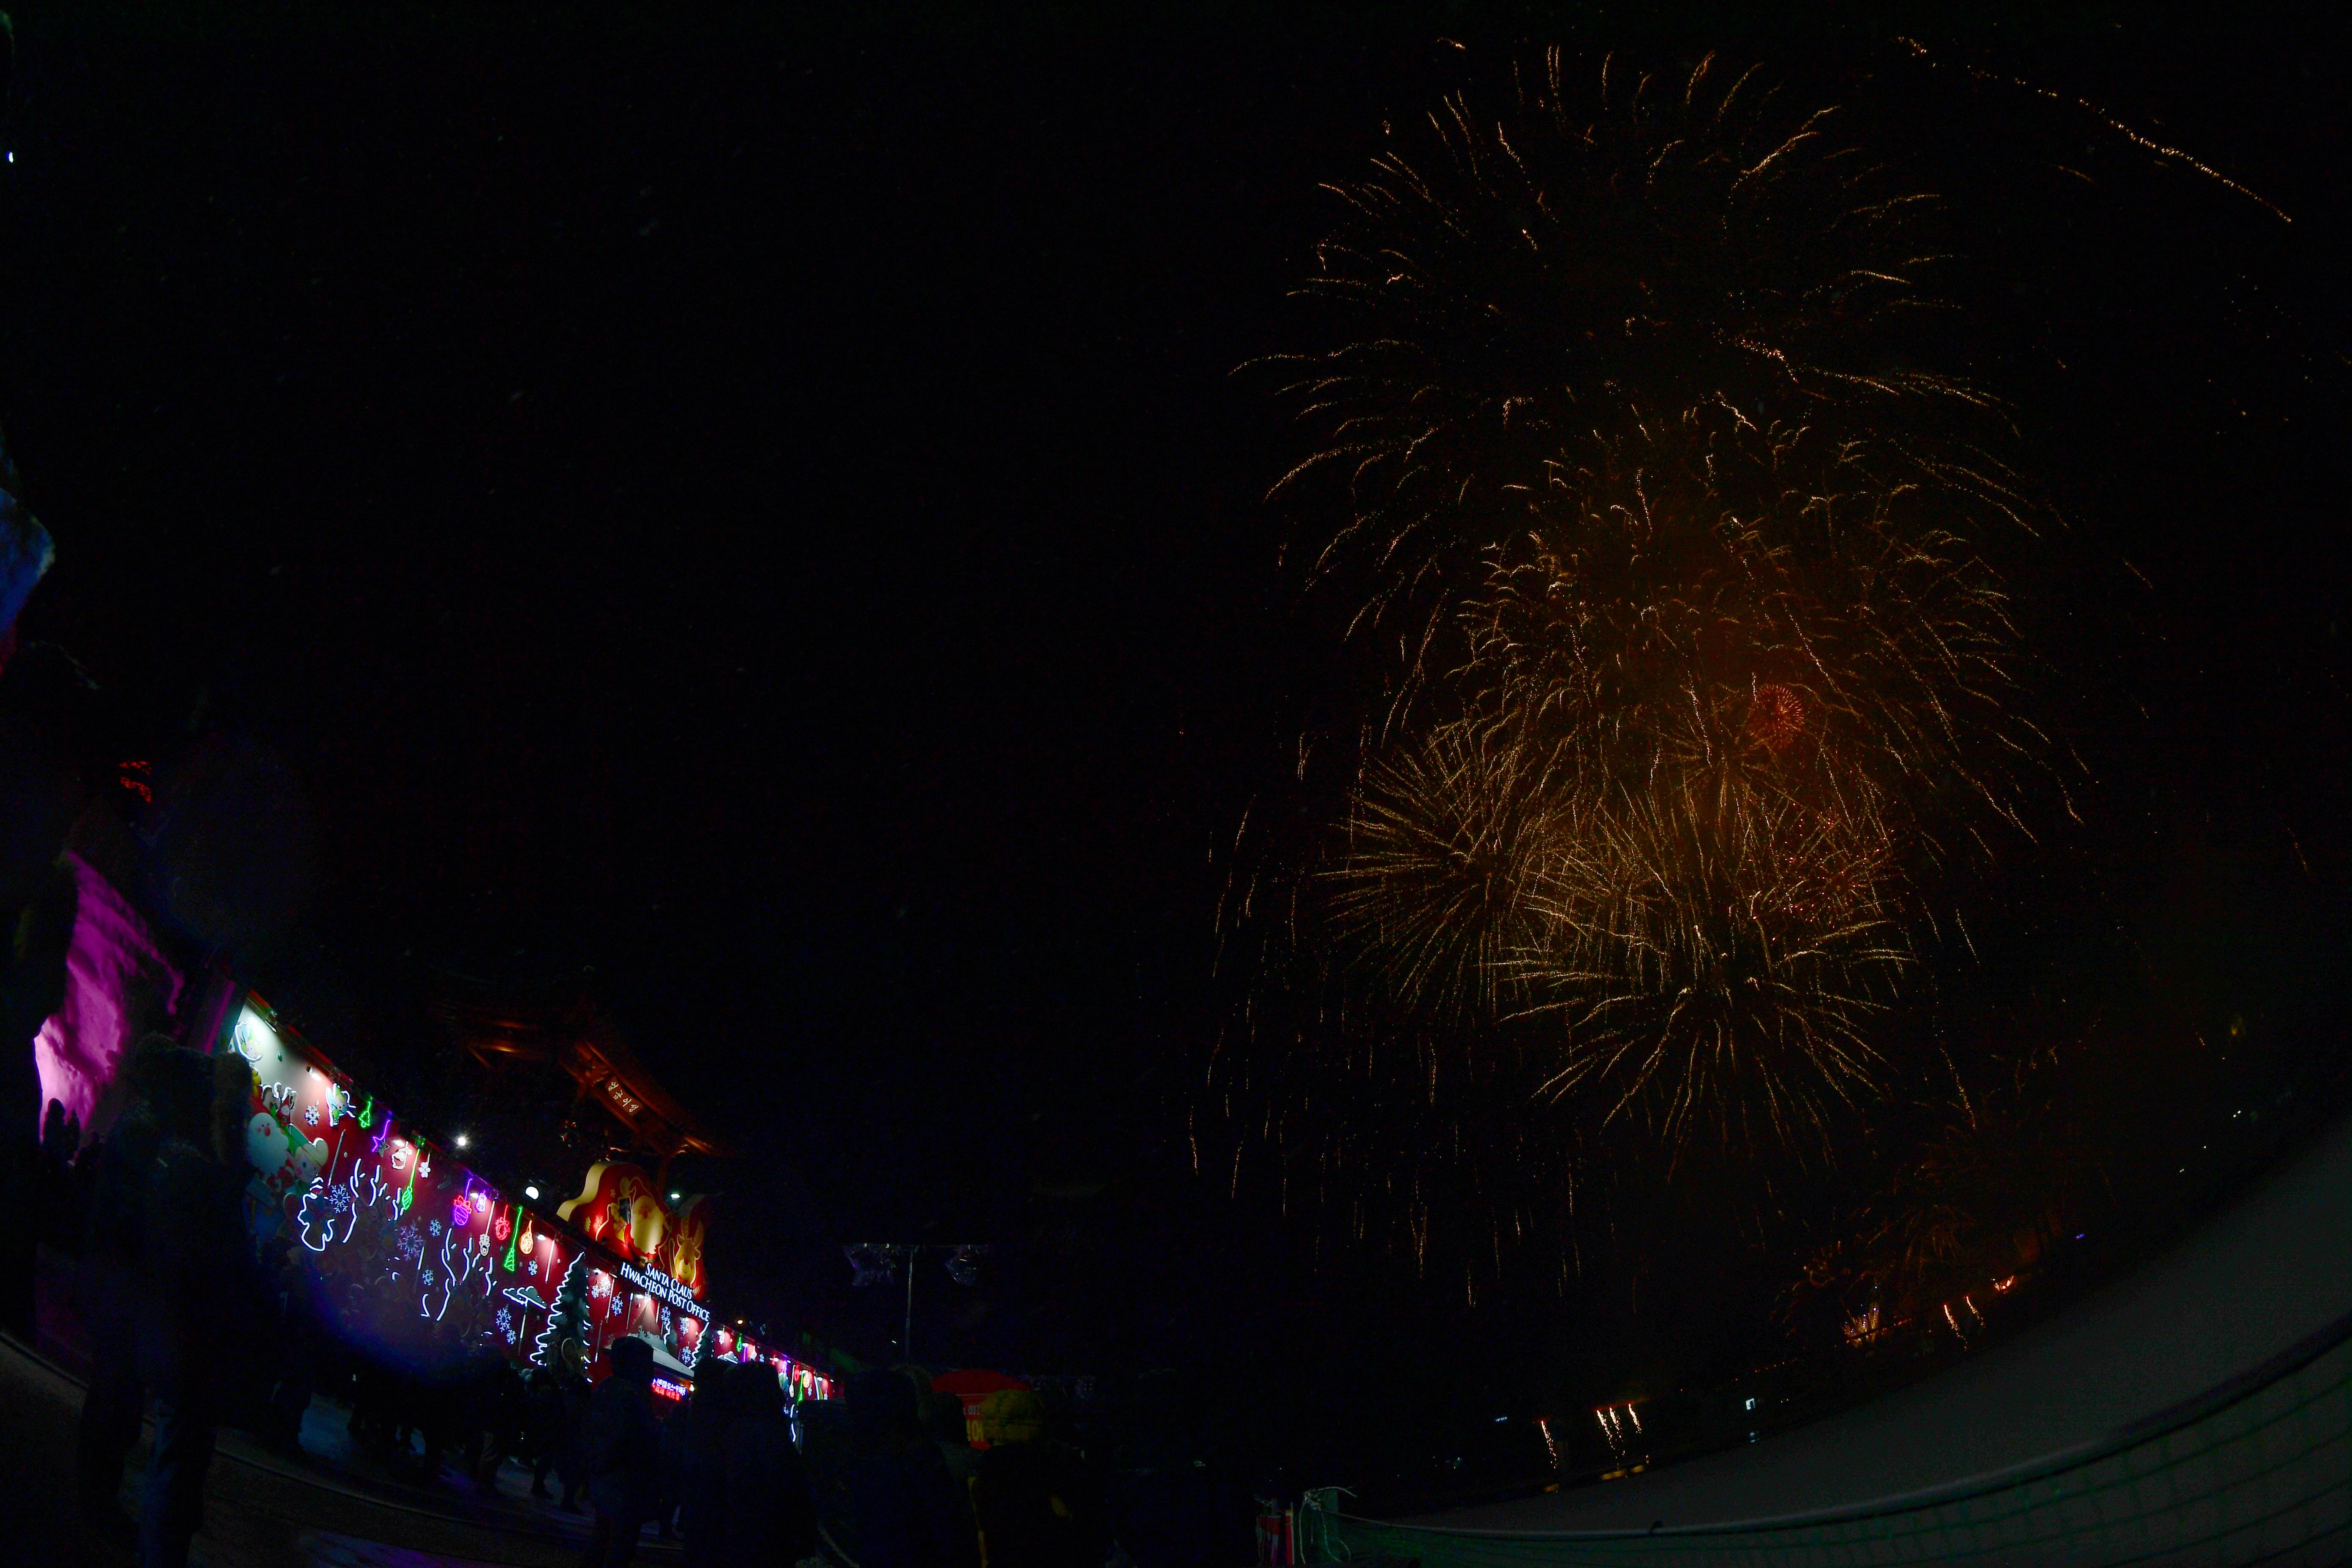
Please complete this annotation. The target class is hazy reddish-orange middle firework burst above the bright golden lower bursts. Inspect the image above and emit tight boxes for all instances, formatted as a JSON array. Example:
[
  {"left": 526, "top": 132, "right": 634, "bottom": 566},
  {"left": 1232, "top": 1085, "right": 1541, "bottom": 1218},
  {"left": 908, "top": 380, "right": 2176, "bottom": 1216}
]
[{"left": 1456, "top": 404, "right": 2016, "bottom": 818}]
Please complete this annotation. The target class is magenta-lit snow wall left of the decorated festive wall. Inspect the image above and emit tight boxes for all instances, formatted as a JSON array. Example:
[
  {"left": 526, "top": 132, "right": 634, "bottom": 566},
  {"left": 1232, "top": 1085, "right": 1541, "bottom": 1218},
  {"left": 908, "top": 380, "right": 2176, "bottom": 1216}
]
[{"left": 33, "top": 853, "right": 181, "bottom": 1138}]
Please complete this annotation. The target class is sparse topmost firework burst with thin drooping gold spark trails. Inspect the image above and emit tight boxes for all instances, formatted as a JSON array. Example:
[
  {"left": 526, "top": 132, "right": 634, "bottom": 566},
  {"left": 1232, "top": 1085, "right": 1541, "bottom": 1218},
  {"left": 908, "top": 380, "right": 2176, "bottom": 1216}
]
[{"left": 1263, "top": 49, "right": 1985, "bottom": 658}]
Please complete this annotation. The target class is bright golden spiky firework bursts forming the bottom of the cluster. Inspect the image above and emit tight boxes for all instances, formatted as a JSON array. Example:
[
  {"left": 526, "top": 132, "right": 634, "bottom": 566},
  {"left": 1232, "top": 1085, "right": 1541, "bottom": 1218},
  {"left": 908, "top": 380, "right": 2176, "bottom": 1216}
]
[{"left": 1331, "top": 667, "right": 1908, "bottom": 1147}]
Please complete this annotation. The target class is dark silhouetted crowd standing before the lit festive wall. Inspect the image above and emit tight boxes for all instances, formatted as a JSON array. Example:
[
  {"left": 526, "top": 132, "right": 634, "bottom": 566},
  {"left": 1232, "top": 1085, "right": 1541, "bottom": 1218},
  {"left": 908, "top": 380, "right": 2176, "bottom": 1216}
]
[{"left": 25, "top": 1037, "right": 1185, "bottom": 1568}]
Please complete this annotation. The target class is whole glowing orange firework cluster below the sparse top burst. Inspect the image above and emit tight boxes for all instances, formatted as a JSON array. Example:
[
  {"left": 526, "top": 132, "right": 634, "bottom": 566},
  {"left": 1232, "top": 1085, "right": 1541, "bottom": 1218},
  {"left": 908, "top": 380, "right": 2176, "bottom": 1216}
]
[{"left": 1329, "top": 409, "right": 2016, "bottom": 1147}]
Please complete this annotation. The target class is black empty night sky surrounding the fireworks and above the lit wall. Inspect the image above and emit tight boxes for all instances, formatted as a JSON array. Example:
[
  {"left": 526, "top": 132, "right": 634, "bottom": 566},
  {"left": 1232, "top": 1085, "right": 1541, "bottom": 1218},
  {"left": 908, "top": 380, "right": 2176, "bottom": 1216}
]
[{"left": 0, "top": 5, "right": 2352, "bottom": 1495}]
